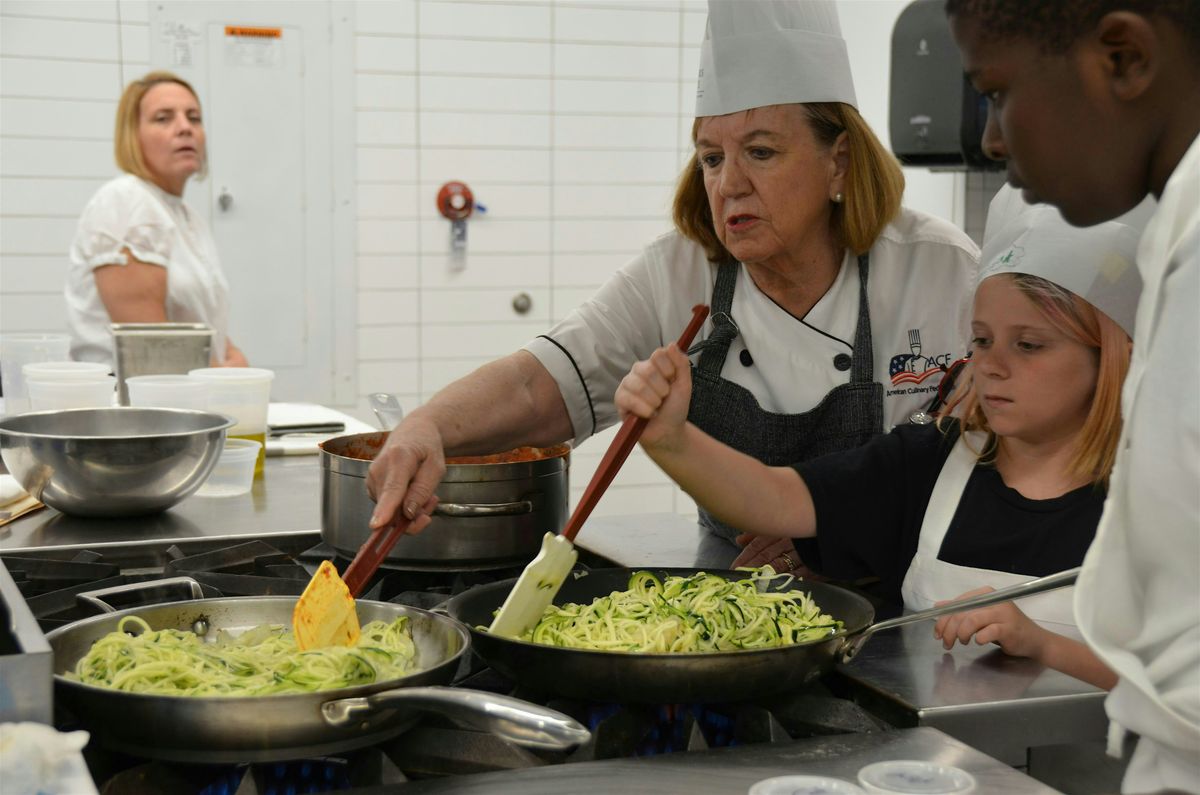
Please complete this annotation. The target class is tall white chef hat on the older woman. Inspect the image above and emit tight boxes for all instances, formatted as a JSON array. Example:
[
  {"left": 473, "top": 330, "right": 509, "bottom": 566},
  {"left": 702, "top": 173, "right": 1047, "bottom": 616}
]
[{"left": 696, "top": 0, "right": 857, "bottom": 118}]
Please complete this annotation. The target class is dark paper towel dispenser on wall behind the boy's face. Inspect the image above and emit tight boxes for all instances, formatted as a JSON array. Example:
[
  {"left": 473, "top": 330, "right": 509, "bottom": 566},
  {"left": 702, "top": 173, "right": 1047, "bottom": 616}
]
[{"left": 888, "top": 0, "right": 1004, "bottom": 171}]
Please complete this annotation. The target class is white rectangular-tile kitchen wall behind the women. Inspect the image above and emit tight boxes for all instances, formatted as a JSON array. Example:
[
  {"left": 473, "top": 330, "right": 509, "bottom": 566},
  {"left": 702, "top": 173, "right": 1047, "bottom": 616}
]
[{"left": 0, "top": 0, "right": 960, "bottom": 523}]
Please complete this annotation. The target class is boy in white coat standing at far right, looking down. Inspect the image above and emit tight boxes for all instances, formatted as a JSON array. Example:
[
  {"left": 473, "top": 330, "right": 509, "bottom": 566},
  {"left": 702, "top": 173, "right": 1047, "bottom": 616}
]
[{"left": 946, "top": 0, "right": 1200, "bottom": 793}]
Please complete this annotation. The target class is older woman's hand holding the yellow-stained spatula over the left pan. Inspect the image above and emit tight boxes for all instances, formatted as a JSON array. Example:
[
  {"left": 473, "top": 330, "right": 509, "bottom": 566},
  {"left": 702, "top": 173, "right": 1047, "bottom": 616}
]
[{"left": 367, "top": 411, "right": 446, "bottom": 533}]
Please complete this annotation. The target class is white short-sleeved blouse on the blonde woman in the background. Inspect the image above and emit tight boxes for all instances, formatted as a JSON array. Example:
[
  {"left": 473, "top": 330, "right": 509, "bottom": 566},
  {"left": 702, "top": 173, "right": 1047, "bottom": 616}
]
[{"left": 64, "top": 174, "right": 229, "bottom": 365}]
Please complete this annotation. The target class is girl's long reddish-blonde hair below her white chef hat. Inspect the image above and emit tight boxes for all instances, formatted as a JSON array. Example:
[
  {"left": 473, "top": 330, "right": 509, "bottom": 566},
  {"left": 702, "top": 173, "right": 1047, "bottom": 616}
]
[{"left": 938, "top": 274, "right": 1129, "bottom": 486}]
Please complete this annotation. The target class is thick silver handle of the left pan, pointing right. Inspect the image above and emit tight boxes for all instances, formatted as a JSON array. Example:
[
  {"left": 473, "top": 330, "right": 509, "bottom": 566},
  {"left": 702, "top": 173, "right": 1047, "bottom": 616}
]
[{"left": 320, "top": 687, "right": 592, "bottom": 751}]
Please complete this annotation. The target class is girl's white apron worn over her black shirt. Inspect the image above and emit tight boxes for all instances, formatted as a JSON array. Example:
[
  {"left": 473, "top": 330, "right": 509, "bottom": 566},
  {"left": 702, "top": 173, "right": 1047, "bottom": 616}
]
[{"left": 900, "top": 431, "right": 1079, "bottom": 638}]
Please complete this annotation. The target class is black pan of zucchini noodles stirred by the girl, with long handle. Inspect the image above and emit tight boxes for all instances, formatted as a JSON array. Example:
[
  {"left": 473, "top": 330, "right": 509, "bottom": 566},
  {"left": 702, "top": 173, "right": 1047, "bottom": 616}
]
[{"left": 444, "top": 568, "right": 1078, "bottom": 704}]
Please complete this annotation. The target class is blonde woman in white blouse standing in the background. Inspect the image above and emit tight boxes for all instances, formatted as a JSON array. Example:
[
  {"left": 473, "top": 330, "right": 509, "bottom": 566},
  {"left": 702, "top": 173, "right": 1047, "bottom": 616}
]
[{"left": 64, "top": 72, "right": 246, "bottom": 366}]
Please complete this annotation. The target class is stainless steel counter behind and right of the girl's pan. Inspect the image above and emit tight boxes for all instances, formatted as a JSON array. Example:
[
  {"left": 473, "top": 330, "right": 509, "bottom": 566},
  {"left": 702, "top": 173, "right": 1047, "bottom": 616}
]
[{"left": 575, "top": 514, "right": 1108, "bottom": 765}]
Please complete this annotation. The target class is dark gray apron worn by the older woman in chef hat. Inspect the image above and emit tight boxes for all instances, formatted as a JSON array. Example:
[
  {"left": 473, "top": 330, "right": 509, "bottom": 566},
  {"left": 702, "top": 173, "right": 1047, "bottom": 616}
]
[{"left": 688, "top": 253, "right": 883, "bottom": 568}]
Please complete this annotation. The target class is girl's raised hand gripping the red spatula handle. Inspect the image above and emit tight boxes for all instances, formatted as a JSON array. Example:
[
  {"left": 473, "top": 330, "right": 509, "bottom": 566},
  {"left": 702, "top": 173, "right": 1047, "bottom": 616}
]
[{"left": 614, "top": 342, "right": 691, "bottom": 450}]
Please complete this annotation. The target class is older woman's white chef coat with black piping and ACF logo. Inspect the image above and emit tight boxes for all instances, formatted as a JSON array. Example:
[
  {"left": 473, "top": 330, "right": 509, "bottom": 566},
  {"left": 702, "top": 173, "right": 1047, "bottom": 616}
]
[{"left": 524, "top": 209, "right": 979, "bottom": 443}]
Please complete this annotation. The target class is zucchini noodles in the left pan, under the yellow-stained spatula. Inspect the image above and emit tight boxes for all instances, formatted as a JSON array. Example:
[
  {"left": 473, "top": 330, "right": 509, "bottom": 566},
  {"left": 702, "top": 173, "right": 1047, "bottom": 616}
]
[{"left": 67, "top": 616, "right": 416, "bottom": 697}]
